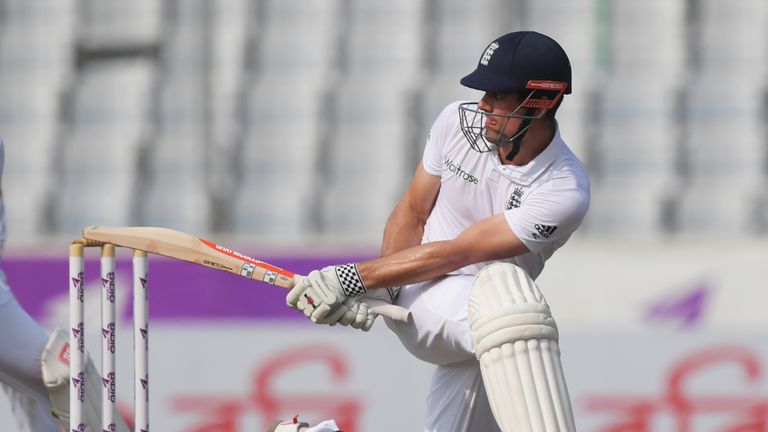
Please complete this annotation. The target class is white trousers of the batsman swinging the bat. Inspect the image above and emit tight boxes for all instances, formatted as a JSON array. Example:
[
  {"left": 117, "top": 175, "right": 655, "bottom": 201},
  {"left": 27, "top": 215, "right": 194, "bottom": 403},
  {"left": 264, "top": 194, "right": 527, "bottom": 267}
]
[{"left": 385, "top": 275, "right": 499, "bottom": 432}]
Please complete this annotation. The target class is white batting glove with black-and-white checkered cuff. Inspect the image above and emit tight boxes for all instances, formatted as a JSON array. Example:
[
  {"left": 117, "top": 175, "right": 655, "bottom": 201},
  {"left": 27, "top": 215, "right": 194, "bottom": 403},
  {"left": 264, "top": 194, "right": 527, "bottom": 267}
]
[{"left": 285, "top": 263, "right": 367, "bottom": 323}]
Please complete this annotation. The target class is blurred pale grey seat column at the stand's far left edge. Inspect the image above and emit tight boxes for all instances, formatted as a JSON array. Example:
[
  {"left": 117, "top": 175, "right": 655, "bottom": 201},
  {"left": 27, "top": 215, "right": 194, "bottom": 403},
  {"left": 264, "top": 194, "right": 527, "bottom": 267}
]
[{"left": 0, "top": 0, "right": 77, "bottom": 238}]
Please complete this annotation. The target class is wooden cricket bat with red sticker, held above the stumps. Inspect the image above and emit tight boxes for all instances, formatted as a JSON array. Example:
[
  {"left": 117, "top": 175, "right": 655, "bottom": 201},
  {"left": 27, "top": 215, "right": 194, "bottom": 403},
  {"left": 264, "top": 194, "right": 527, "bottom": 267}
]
[{"left": 83, "top": 226, "right": 410, "bottom": 322}]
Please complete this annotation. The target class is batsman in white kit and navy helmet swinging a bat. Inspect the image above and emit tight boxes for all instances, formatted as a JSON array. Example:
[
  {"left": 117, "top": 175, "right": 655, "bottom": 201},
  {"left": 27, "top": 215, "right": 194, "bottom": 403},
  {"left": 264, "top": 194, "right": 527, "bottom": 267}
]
[{"left": 286, "top": 31, "right": 589, "bottom": 432}]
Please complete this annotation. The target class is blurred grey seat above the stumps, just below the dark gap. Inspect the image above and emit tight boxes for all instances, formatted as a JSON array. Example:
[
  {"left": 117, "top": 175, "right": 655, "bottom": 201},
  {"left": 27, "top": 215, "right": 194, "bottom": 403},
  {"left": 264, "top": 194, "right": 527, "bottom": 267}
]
[{"left": 54, "top": 59, "right": 154, "bottom": 232}]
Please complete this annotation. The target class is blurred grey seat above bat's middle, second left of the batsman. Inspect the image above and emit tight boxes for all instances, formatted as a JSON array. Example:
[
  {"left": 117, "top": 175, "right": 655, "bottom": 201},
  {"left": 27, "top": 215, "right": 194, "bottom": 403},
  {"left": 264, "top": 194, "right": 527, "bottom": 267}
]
[{"left": 231, "top": 79, "right": 325, "bottom": 236}]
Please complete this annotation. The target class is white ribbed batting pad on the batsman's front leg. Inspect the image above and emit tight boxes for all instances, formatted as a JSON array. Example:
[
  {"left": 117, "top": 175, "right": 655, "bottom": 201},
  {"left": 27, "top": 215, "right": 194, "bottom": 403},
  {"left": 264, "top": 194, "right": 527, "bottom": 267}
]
[{"left": 468, "top": 263, "right": 576, "bottom": 432}]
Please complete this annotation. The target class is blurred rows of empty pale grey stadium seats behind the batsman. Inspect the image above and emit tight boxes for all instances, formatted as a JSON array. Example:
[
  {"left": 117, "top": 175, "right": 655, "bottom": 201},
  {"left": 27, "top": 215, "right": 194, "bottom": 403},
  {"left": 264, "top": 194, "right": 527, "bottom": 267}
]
[{"left": 0, "top": 0, "right": 768, "bottom": 241}]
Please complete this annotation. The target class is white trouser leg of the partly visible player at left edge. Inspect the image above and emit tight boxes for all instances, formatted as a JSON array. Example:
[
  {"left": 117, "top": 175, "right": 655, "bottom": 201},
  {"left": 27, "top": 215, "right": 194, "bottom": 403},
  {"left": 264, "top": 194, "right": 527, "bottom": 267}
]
[{"left": 0, "top": 280, "right": 59, "bottom": 432}]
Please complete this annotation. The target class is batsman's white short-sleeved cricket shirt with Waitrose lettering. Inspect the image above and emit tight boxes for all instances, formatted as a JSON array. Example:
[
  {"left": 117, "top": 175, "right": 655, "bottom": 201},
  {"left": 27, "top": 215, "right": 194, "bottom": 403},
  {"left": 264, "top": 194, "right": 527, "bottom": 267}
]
[{"left": 422, "top": 102, "right": 589, "bottom": 279}]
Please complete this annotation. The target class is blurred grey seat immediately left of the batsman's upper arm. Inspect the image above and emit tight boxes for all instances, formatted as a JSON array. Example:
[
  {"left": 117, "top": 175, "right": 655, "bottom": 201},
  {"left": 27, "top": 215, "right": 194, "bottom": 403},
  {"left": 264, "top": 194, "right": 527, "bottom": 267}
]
[{"left": 321, "top": 77, "right": 414, "bottom": 236}]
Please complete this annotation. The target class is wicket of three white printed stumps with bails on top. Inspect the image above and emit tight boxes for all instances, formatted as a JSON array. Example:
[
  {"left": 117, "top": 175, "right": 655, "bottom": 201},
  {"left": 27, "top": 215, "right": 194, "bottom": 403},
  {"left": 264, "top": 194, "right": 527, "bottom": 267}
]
[{"left": 69, "top": 240, "right": 149, "bottom": 432}]
